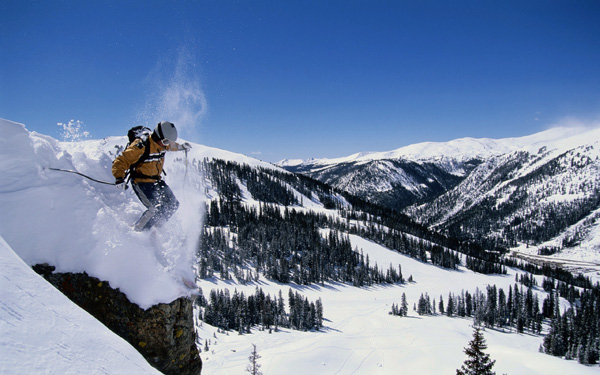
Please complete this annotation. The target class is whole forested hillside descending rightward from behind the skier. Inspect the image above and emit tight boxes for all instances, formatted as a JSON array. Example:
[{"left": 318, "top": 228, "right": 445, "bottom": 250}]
[{"left": 198, "top": 159, "right": 505, "bottom": 286}]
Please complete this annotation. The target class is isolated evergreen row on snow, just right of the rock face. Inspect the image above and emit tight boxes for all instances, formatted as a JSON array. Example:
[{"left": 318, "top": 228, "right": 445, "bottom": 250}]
[{"left": 200, "top": 287, "right": 323, "bottom": 334}]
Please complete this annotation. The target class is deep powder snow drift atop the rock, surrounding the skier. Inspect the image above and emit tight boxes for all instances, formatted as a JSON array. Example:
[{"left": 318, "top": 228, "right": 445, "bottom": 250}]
[{"left": 0, "top": 120, "right": 206, "bottom": 308}]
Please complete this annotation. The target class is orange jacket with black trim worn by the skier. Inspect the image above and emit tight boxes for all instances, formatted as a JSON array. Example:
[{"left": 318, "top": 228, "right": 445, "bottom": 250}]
[{"left": 112, "top": 136, "right": 182, "bottom": 183}]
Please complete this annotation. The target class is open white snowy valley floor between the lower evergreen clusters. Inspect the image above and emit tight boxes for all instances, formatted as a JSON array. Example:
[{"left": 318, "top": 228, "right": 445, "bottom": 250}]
[{"left": 198, "top": 236, "right": 600, "bottom": 375}]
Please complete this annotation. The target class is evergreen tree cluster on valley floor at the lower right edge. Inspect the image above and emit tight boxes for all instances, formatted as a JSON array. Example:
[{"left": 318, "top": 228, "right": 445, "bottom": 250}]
[{"left": 398, "top": 274, "right": 600, "bottom": 370}]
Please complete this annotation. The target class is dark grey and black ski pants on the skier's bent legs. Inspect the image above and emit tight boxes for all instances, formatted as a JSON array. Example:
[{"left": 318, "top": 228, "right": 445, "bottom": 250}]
[{"left": 131, "top": 180, "right": 179, "bottom": 231}]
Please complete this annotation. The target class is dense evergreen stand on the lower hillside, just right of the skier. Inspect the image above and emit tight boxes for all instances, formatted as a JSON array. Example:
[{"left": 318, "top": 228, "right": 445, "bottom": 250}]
[{"left": 198, "top": 200, "right": 404, "bottom": 286}]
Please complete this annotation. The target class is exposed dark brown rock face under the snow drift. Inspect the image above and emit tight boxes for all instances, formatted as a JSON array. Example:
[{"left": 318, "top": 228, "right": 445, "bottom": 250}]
[{"left": 33, "top": 265, "right": 202, "bottom": 375}]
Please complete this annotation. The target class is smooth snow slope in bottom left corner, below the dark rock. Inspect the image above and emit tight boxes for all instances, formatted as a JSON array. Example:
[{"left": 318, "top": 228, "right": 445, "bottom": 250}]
[{"left": 0, "top": 237, "right": 159, "bottom": 375}]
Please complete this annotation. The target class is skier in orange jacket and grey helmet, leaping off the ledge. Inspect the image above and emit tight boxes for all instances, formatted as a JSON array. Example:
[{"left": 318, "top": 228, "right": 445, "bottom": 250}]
[{"left": 112, "top": 121, "right": 192, "bottom": 231}]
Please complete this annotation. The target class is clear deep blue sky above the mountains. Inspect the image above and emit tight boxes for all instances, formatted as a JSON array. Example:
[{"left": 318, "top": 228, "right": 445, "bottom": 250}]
[{"left": 0, "top": 0, "right": 600, "bottom": 162}]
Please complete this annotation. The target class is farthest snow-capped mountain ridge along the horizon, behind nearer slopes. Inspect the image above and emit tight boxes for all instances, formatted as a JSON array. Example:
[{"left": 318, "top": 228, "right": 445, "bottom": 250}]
[{"left": 278, "top": 126, "right": 599, "bottom": 216}]
